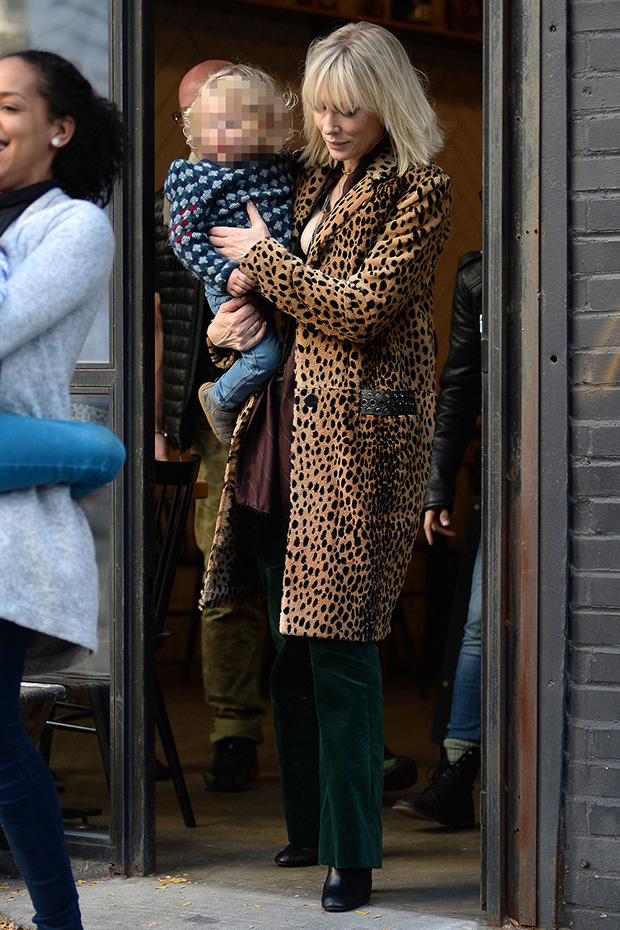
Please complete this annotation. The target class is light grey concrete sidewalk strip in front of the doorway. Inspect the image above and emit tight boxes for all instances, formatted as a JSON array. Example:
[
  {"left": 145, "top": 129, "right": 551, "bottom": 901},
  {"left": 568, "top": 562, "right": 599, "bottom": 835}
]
[{"left": 0, "top": 876, "right": 482, "bottom": 930}]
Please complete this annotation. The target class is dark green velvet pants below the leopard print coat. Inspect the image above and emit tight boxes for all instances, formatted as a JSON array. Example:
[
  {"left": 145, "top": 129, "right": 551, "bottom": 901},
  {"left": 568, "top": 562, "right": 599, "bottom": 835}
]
[{"left": 259, "top": 520, "right": 384, "bottom": 869}]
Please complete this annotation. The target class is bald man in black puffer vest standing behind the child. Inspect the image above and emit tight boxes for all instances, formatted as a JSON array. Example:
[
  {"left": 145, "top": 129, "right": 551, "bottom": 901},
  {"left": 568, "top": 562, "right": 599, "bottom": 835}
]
[{"left": 155, "top": 61, "right": 265, "bottom": 791}]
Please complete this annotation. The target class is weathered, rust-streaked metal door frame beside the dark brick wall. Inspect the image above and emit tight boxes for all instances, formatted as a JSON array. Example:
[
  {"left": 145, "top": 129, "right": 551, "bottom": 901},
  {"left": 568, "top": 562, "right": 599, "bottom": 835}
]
[{"left": 481, "top": 0, "right": 569, "bottom": 930}]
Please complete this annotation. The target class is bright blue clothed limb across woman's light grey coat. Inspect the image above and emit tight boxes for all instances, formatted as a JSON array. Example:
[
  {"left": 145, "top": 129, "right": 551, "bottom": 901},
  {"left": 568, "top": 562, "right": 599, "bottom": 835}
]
[{"left": 0, "top": 413, "right": 125, "bottom": 500}]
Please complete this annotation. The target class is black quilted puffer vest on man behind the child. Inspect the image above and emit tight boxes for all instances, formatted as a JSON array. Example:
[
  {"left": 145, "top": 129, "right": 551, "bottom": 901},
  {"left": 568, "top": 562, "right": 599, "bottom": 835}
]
[{"left": 155, "top": 190, "right": 222, "bottom": 449}]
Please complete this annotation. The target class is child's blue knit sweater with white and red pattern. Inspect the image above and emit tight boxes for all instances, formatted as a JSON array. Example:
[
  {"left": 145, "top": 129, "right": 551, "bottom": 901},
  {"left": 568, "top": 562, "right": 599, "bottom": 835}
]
[{"left": 164, "top": 152, "right": 294, "bottom": 293}]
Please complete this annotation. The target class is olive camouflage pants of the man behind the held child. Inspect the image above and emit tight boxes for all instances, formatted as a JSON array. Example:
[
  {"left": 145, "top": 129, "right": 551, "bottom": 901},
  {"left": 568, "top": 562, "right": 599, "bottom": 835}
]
[{"left": 192, "top": 417, "right": 265, "bottom": 743}]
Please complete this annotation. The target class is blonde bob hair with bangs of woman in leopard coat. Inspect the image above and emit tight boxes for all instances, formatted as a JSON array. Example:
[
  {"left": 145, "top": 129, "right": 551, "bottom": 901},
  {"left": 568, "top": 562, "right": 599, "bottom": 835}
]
[{"left": 301, "top": 22, "right": 443, "bottom": 174}]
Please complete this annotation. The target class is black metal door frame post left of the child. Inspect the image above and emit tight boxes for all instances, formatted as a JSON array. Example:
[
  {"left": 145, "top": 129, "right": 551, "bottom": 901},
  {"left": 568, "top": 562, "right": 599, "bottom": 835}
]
[{"left": 66, "top": 0, "right": 155, "bottom": 875}]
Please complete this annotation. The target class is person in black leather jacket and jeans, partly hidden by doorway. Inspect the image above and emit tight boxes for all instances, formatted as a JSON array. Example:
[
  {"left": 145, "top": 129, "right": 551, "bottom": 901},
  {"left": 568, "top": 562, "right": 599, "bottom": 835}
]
[{"left": 394, "top": 252, "right": 482, "bottom": 829}]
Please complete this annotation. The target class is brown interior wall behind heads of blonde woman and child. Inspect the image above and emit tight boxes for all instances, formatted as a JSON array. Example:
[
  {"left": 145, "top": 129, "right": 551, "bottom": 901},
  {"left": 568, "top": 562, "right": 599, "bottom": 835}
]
[{"left": 155, "top": 0, "right": 482, "bottom": 376}]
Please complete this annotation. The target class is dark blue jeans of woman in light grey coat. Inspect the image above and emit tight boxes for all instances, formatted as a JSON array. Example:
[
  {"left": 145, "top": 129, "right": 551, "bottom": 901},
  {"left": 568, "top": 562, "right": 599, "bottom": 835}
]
[{"left": 0, "top": 620, "right": 82, "bottom": 930}]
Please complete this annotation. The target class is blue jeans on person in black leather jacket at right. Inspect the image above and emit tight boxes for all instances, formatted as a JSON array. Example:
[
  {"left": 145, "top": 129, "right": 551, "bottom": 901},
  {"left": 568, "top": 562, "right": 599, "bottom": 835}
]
[{"left": 448, "top": 542, "right": 482, "bottom": 742}]
